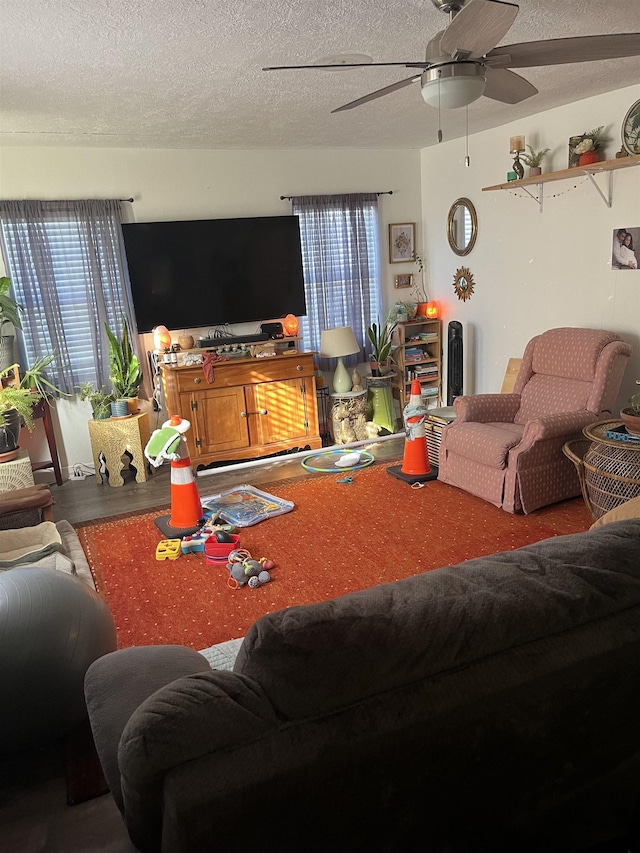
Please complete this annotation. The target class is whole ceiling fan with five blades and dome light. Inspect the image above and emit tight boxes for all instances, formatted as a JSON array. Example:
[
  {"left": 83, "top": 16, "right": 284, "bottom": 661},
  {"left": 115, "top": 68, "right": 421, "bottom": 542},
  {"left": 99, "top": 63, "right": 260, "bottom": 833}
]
[{"left": 262, "top": 0, "right": 640, "bottom": 113}]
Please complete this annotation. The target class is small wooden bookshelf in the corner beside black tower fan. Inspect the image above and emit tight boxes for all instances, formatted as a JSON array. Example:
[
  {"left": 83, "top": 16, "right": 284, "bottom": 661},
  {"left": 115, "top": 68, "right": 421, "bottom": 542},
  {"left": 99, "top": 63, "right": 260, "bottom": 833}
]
[{"left": 393, "top": 318, "right": 442, "bottom": 407}]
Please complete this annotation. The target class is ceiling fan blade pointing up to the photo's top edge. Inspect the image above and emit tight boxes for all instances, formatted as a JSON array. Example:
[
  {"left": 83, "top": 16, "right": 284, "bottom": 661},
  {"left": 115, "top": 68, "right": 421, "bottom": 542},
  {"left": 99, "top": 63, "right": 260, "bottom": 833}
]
[{"left": 440, "top": 0, "right": 519, "bottom": 59}]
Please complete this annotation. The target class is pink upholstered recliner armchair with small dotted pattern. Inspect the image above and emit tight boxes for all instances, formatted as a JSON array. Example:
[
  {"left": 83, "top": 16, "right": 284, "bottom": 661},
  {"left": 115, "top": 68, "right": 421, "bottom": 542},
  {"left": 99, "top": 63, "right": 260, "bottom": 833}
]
[{"left": 438, "top": 328, "right": 631, "bottom": 513}]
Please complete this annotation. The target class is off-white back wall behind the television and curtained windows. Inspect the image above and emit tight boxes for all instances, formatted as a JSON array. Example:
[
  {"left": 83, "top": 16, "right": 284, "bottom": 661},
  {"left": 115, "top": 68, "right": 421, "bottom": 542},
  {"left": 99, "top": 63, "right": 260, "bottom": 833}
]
[{"left": 0, "top": 148, "right": 421, "bottom": 480}]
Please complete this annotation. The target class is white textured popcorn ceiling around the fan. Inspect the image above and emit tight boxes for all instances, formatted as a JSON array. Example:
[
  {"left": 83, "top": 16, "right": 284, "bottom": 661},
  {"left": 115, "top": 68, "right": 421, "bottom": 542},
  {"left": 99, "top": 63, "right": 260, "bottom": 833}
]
[{"left": 0, "top": 0, "right": 640, "bottom": 149}]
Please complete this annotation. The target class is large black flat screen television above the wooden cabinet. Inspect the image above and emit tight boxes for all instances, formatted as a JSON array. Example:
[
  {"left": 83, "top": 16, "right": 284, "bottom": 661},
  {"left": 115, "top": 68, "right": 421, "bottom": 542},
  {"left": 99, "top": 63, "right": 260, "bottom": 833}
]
[{"left": 122, "top": 216, "right": 307, "bottom": 332}]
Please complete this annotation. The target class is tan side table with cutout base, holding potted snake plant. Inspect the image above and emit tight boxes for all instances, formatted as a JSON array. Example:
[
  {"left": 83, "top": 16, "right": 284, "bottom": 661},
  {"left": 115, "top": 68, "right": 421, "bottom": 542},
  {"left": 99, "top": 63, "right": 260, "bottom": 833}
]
[{"left": 89, "top": 412, "right": 151, "bottom": 486}]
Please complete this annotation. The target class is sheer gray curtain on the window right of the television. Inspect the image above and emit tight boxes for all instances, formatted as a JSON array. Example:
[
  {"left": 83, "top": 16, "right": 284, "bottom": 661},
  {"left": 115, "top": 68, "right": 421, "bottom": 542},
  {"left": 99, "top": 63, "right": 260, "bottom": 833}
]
[{"left": 292, "top": 193, "right": 381, "bottom": 370}]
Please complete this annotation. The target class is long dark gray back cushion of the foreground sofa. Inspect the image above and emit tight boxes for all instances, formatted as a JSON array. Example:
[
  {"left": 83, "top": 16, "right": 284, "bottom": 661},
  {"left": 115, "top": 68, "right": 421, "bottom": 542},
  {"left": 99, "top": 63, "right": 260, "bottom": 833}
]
[{"left": 234, "top": 519, "right": 640, "bottom": 719}]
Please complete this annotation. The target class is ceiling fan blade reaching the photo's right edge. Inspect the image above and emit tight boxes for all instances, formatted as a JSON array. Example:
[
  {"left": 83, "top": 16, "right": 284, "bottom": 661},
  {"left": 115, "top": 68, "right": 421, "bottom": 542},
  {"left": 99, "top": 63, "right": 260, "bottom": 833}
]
[{"left": 484, "top": 32, "right": 640, "bottom": 68}]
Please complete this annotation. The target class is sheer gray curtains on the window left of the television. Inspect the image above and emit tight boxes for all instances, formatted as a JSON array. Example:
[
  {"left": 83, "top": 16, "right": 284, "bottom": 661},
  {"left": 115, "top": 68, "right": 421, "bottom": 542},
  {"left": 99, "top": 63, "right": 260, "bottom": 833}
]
[{"left": 0, "top": 199, "right": 137, "bottom": 393}]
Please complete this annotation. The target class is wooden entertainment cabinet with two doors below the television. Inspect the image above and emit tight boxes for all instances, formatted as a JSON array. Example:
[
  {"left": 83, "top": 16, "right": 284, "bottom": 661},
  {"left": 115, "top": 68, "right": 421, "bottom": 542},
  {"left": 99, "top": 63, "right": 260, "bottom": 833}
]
[{"left": 160, "top": 352, "right": 322, "bottom": 466}]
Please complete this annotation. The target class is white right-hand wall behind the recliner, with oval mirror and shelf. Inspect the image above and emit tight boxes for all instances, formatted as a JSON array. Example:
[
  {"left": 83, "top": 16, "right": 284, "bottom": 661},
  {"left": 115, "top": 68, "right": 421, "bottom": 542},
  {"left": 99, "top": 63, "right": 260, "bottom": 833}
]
[{"left": 421, "top": 86, "right": 640, "bottom": 408}]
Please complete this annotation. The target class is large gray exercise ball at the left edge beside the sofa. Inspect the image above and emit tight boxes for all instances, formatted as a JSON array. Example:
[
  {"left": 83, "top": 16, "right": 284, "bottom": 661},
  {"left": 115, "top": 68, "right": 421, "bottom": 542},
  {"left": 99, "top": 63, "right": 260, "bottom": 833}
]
[{"left": 0, "top": 566, "right": 116, "bottom": 752}]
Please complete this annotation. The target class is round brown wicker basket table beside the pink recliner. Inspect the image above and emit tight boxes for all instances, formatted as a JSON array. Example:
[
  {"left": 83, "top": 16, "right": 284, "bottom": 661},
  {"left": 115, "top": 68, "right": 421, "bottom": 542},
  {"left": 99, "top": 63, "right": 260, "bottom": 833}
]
[{"left": 563, "top": 421, "right": 640, "bottom": 518}]
